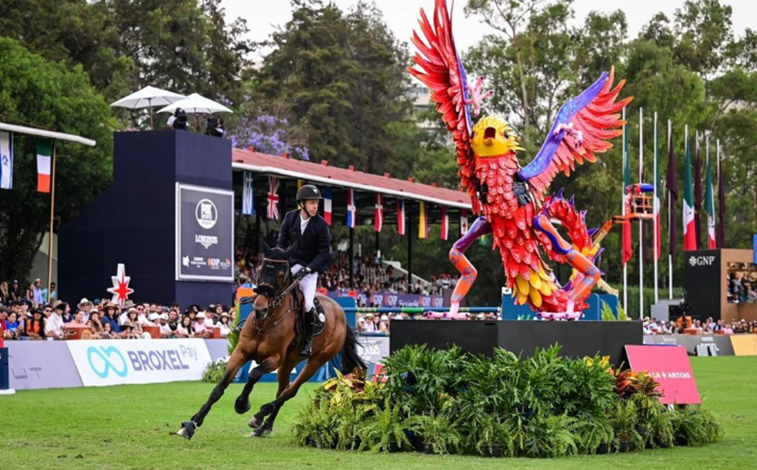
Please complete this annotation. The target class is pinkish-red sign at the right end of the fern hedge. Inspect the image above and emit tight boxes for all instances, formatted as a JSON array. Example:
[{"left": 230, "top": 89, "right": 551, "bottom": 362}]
[{"left": 626, "top": 345, "right": 702, "bottom": 405}]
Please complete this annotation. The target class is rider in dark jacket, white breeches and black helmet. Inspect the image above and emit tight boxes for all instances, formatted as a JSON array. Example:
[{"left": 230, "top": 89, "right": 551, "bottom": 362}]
[{"left": 276, "top": 184, "right": 331, "bottom": 356}]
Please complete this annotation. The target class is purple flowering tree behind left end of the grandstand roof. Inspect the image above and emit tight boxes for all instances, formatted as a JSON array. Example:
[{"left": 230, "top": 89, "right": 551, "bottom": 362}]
[{"left": 224, "top": 95, "right": 310, "bottom": 161}]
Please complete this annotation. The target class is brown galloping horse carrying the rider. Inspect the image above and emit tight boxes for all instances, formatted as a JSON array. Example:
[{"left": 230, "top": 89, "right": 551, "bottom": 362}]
[{"left": 177, "top": 243, "right": 366, "bottom": 439}]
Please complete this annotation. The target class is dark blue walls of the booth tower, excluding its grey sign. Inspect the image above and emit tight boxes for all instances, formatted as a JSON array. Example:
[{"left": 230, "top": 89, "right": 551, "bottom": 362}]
[{"left": 58, "top": 130, "right": 233, "bottom": 306}]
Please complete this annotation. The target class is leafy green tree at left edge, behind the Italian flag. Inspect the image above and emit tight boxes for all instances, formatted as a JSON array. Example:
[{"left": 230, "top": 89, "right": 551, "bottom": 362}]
[{"left": 0, "top": 38, "right": 116, "bottom": 279}]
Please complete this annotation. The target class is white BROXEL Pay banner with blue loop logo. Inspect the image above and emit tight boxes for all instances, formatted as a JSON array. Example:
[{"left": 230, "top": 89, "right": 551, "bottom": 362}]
[{"left": 66, "top": 339, "right": 210, "bottom": 387}]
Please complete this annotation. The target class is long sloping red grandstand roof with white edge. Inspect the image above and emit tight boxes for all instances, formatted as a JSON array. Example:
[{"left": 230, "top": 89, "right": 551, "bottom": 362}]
[{"left": 232, "top": 149, "right": 471, "bottom": 209}]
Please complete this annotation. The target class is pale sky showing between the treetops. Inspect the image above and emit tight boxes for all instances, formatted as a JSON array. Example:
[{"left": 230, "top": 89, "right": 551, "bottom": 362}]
[{"left": 221, "top": 0, "right": 757, "bottom": 60}]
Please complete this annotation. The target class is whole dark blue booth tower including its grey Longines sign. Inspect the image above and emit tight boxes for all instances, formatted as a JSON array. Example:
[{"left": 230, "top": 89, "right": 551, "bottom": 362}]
[{"left": 58, "top": 130, "right": 234, "bottom": 305}]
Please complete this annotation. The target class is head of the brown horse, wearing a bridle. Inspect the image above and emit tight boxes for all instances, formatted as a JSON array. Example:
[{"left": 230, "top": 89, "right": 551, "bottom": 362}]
[{"left": 252, "top": 241, "right": 296, "bottom": 320}]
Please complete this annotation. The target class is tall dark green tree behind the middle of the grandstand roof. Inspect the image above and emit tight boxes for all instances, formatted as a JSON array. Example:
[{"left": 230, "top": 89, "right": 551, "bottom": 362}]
[{"left": 255, "top": 0, "right": 411, "bottom": 173}]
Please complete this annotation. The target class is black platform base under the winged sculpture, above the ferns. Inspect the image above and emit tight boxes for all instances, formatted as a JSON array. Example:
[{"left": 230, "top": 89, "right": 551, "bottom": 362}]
[{"left": 389, "top": 320, "right": 644, "bottom": 366}]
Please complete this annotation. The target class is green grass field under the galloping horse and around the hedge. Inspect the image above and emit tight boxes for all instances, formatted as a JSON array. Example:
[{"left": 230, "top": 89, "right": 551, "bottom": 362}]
[{"left": 0, "top": 357, "right": 757, "bottom": 470}]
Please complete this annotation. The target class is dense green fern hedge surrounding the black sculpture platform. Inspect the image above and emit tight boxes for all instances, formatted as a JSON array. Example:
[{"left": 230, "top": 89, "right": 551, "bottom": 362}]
[{"left": 293, "top": 346, "right": 723, "bottom": 458}]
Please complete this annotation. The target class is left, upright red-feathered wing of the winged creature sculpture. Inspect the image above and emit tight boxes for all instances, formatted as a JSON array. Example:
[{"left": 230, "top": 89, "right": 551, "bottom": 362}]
[{"left": 408, "top": 0, "right": 480, "bottom": 214}]
